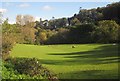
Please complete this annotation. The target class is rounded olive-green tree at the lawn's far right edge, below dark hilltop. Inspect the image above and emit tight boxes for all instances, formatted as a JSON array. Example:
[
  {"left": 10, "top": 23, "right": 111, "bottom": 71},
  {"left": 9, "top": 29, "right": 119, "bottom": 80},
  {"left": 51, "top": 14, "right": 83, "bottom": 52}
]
[{"left": 94, "top": 20, "right": 120, "bottom": 43}]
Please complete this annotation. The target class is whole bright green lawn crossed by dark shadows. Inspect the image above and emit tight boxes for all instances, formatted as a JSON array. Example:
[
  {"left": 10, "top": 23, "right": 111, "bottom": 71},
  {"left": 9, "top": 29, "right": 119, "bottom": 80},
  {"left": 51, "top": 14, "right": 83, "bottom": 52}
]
[{"left": 11, "top": 44, "right": 119, "bottom": 79}]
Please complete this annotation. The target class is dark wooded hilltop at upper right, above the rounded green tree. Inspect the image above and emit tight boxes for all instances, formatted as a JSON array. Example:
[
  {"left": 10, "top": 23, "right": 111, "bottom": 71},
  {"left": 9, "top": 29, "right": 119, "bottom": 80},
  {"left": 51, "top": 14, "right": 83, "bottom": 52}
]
[{"left": 76, "top": 2, "right": 120, "bottom": 24}]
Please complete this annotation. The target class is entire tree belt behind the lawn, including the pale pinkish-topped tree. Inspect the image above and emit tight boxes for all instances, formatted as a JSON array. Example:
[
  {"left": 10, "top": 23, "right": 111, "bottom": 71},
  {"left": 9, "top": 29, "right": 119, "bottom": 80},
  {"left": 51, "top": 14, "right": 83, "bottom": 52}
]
[{"left": 13, "top": 2, "right": 120, "bottom": 45}]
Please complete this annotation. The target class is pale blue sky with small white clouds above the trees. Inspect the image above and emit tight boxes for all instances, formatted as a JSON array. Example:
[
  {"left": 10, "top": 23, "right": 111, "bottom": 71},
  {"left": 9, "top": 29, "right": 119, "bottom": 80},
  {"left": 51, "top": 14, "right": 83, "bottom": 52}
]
[{"left": 0, "top": 2, "right": 119, "bottom": 24}]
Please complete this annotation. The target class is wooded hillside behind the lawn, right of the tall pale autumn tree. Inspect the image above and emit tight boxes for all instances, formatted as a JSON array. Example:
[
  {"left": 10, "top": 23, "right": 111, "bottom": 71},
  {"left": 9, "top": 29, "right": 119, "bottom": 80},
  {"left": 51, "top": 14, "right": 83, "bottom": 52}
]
[{"left": 33, "top": 2, "right": 120, "bottom": 44}]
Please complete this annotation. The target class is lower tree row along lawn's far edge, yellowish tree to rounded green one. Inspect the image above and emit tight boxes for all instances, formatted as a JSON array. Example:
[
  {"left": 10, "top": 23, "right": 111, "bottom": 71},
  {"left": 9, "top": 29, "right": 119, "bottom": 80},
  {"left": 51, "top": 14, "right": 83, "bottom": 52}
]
[{"left": 36, "top": 20, "right": 119, "bottom": 44}]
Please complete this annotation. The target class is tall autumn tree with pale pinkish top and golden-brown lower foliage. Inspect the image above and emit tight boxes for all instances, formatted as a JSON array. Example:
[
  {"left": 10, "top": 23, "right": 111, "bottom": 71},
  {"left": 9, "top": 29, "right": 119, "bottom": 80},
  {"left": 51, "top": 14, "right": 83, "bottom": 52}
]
[{"left": 16, "top": 15, "right": 36, "bottom": 44}]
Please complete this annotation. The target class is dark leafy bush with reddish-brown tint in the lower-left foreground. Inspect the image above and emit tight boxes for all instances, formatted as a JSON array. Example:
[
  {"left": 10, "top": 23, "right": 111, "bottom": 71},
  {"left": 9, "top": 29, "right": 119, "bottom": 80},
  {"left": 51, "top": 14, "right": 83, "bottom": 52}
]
[{"left": 14, "top": 58, "right": 43, "bottom": 76}]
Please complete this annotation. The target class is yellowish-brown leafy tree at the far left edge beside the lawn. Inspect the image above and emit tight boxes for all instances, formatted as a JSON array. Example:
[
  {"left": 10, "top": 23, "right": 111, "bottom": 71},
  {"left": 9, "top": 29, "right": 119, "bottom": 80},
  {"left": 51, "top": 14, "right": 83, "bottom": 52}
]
[{"left": 2, "top": 19, "right": 18, "bottom": 59}]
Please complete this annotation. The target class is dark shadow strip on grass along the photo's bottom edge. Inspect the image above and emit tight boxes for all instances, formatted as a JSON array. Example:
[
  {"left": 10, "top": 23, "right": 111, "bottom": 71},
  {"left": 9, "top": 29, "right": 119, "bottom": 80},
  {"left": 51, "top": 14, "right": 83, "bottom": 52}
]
[{"left": 59, "top": 70, "right": 119, "bottom": 79}]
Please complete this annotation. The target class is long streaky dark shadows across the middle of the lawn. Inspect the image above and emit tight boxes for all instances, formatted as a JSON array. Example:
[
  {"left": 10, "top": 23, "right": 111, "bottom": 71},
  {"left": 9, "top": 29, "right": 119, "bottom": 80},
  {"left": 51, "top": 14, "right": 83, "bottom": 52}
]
[{"left": 41, "top": 45, "right": 120, "bottom": 65}]
